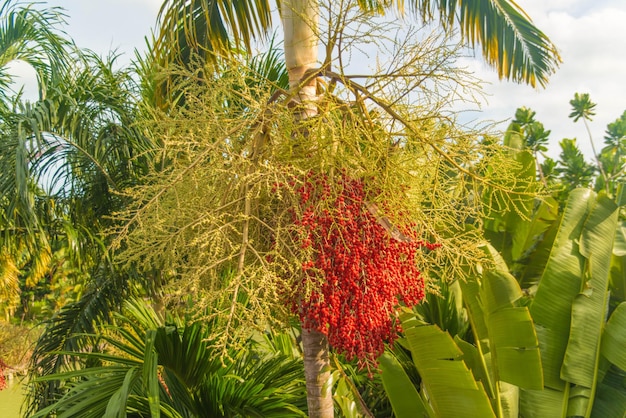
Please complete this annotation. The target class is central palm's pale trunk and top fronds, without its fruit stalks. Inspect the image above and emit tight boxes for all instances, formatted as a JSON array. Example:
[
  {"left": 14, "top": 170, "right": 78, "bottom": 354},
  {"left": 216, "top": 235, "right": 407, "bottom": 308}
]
[{"left": 155, "top": 0, "right": 560, "bottom": 417}]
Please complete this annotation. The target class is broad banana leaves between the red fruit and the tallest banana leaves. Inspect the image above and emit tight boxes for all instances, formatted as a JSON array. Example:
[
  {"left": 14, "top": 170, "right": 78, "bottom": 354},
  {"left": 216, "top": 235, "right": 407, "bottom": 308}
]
[{"left": 380, "top": 244, "right": 543, "bottom": 418}]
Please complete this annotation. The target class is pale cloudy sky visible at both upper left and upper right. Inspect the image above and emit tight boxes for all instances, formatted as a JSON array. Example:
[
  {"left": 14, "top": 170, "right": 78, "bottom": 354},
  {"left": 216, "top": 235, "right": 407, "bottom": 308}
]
[{"left": 8, "top": 0, "right": 626, "bottom": 157}]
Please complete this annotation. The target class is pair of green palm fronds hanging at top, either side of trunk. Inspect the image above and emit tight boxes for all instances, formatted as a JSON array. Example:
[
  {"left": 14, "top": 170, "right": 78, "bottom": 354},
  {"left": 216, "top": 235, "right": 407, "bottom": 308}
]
[{"left": 155, "top": 0, "right": 560, "bottom": 86}]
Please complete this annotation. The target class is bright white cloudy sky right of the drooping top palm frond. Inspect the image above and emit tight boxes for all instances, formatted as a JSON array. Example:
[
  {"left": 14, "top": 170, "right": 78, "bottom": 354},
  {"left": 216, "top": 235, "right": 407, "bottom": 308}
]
[{"left": 460, "top": 0, "right": 626, "bottom": 156}]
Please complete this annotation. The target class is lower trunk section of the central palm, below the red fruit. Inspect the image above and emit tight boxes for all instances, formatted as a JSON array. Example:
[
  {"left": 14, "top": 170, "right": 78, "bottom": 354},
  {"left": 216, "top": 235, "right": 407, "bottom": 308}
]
[{"left": 302, "top": 329, "right": 334, "bottom": 418}]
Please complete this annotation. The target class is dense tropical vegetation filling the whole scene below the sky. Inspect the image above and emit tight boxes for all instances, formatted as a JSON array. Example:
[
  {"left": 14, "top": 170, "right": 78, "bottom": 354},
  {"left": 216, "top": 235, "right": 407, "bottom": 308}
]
[{"left": 0, "top": 0, "right": 626, "bottom": 418}]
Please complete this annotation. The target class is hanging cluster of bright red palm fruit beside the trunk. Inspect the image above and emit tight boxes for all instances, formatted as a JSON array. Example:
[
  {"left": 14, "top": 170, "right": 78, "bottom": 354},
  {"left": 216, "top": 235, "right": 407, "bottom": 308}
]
[{"left": 293, "top": 173, "right": 438, "bottom": 368}]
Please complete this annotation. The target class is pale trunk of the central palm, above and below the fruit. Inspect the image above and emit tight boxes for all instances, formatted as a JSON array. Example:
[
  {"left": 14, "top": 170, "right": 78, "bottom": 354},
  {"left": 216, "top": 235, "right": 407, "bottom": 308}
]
[{"left": 281, "top": 0, "right": 334, "bottom": 418}]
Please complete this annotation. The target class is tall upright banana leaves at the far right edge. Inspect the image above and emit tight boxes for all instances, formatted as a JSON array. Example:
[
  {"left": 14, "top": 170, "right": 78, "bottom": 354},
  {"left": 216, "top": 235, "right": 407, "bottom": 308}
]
[{"left": 520, "top": 189, "right": 626, "bottom": 417}]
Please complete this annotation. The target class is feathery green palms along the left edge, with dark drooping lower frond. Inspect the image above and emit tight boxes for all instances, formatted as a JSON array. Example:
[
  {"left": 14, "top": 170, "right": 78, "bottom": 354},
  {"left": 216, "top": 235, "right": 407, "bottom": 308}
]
[{"left": 0, "top": 1, "right": 163, "bottom": 410}]
